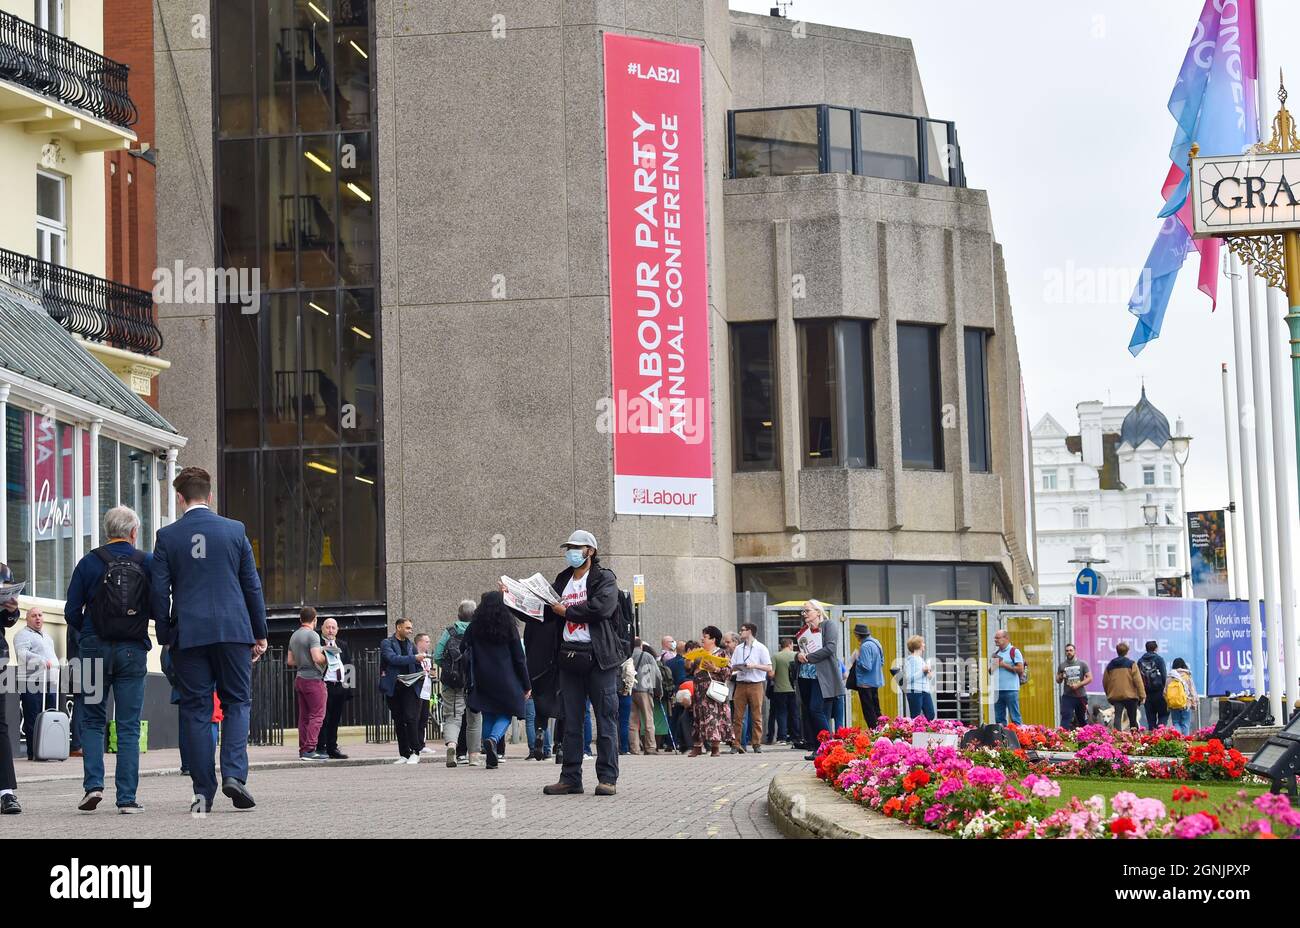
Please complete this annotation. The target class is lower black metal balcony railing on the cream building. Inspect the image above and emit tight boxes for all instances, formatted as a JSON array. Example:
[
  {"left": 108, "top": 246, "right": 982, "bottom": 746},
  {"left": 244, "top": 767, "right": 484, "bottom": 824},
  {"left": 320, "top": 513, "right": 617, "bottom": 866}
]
[{"left": 0, "top": 248, "right": 163, "bottom": 355}]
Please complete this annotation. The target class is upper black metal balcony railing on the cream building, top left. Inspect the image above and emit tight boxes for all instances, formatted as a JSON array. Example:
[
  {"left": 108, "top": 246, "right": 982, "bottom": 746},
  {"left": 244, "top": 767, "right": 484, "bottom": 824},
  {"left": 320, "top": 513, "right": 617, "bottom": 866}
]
[{"left": 0, "top": 12, "right": 139, "bottom": 127}]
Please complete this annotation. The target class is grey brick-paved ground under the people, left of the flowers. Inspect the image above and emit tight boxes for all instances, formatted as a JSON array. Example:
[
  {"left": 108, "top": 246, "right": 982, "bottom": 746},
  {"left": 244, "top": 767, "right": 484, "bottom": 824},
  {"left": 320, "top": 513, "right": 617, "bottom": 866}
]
[{"left": 0, "top": 745, "right": 811, "bottom": 840}]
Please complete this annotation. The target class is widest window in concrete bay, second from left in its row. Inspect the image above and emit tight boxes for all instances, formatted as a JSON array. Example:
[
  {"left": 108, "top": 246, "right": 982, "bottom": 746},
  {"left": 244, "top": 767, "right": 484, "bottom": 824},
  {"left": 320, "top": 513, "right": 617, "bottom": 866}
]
[{"left": 800, "top": 320, "right": 876, "bottom": 467}]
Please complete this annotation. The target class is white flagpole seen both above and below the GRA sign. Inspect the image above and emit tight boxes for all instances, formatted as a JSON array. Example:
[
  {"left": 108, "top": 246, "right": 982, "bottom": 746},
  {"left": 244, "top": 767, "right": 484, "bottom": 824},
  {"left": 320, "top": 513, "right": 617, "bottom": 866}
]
[{"left": 1252, "top": 0, "right": 1296, "bottom": 724}]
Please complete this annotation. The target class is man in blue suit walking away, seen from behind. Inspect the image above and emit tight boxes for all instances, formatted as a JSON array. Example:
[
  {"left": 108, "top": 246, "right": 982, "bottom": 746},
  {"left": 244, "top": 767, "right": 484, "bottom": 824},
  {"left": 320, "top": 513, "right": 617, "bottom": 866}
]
[{"left": 151, "top": 467, "right": 267, "bottom": 814}]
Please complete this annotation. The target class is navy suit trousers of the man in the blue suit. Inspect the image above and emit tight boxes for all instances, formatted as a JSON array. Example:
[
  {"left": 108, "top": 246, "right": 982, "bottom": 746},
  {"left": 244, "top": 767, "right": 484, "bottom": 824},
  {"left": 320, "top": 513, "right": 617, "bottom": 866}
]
[{"left": 172, "top": 642, "right": 252, "bottom": 802}]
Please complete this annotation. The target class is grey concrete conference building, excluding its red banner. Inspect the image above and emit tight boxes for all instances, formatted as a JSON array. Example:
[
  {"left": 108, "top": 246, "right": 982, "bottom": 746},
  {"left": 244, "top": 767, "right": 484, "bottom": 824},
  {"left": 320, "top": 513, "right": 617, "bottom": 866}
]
[{"left": 155, "top": 0, "right": 1036, "bottom": 647}]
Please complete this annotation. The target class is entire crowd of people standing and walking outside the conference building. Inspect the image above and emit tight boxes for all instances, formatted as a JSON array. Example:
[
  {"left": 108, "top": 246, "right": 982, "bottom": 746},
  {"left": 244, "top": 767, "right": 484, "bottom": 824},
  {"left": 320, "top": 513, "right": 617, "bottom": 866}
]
[{"left": 0, "top": 468, "right": 1216, "bottom": 814}]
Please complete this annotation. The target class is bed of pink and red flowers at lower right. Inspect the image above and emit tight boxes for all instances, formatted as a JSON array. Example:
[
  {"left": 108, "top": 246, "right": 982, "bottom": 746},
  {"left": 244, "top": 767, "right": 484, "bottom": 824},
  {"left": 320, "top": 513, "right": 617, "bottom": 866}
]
[{"left": 814, "top": 719, "right": 1300, "bottom": 838}]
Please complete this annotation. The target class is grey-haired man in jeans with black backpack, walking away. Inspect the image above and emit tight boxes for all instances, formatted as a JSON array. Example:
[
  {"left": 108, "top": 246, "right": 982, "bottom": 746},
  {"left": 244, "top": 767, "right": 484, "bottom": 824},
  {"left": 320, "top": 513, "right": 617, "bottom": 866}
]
[{"left": 64, "top": 506, "right": 152, "bottom": 814}]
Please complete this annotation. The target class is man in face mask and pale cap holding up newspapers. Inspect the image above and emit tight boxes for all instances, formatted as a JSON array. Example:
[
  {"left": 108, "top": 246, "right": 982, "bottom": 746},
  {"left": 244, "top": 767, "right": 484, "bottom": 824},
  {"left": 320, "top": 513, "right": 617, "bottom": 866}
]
[{"left": 501, "top": 530, "right": 629, "bottom": 795}]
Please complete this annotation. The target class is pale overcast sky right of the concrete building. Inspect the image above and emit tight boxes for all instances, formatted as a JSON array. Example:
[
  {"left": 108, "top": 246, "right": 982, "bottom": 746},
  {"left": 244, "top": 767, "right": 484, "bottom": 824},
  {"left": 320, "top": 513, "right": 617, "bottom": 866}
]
[{"left": 731, "top": 0, "right": 1300, "bottom": 543}]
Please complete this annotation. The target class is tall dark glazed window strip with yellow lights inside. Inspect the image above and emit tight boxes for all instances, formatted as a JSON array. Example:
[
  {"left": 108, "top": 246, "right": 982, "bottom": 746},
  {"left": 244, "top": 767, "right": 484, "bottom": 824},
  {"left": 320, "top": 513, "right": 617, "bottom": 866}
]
[{"left": 213, "top": 0, "right": 384, "bottom": 607}]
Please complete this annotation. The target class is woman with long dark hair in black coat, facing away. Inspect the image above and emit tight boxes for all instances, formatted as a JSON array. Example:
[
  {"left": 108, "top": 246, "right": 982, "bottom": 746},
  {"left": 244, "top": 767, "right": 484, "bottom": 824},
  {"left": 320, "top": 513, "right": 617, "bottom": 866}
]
[{"left": 464, "top": 590, "right": 532, "bottom": 769}]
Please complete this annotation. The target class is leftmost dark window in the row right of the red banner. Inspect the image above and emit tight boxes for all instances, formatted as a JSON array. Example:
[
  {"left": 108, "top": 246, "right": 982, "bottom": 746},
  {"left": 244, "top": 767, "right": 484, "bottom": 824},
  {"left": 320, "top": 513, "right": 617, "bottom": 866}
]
[{"left": 731, "top": 322, "right": 780, "bottom": 470}]
